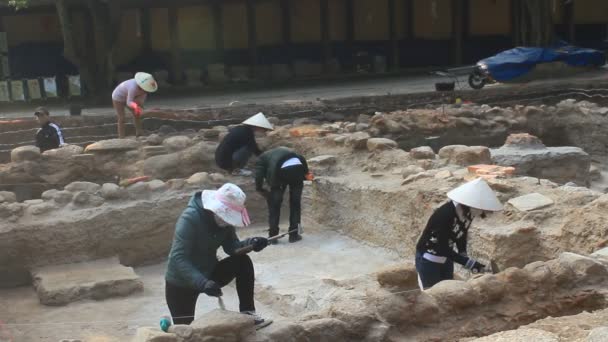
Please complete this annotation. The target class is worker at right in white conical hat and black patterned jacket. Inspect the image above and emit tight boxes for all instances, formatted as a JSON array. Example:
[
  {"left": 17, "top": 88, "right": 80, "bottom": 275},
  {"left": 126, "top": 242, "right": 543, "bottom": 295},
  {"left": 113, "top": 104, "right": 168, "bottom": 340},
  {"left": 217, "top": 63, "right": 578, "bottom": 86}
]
[{"left": 416, "top": 178, "right": 502, "bottom": 290}]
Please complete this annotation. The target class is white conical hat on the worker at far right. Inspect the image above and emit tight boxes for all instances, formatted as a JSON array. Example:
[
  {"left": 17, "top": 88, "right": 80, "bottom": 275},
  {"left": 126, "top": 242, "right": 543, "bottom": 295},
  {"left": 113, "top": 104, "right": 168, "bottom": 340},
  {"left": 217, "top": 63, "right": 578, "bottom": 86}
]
[{"left": 448, "top": 178, "right": 502, "bottom": 211}]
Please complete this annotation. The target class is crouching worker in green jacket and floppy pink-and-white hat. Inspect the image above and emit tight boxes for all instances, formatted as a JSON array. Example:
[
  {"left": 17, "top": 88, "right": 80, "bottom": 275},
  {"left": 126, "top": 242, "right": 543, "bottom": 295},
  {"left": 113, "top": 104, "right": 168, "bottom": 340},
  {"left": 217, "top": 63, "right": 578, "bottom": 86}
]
[{"left": 165, "top": 183, "right": 272, "bottom": 329}]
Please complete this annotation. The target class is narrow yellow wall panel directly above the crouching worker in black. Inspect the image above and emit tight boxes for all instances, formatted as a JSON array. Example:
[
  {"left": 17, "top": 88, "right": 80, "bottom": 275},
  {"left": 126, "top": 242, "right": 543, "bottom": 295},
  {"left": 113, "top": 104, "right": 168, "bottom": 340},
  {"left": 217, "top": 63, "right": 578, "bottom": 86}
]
[{"left": 222, "top": 2, "right": 249, "bottom": 49}]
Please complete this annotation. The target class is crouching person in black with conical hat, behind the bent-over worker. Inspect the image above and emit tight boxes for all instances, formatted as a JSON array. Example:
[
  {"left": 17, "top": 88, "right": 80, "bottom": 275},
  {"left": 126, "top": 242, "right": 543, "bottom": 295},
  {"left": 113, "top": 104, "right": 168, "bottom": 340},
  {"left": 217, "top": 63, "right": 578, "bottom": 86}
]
[{"left": 215, "top": 113, "right": 273, "bottom": 176}]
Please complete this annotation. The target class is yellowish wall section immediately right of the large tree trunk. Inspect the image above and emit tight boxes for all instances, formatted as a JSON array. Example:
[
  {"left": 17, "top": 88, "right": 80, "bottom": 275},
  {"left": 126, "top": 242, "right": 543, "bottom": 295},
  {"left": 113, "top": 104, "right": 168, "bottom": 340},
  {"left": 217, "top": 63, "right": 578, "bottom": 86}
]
[{"left": 114, "top": 10, "right": 143, "bottom": 65}]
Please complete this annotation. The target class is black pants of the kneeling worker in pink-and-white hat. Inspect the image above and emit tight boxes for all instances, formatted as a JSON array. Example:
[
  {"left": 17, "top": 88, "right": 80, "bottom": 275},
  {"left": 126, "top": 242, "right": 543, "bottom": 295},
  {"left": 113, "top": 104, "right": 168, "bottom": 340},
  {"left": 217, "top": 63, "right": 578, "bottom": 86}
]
[{"left": 165, "top": 255, "right": 255, "bottom": 324}]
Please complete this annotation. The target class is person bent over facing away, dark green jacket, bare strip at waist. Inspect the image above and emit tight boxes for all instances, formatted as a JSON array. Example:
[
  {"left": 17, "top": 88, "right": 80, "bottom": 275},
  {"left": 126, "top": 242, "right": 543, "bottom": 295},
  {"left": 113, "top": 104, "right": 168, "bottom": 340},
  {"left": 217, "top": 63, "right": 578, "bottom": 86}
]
[{"left": 255, "top": 147, "right": 309, "bottom": 242}]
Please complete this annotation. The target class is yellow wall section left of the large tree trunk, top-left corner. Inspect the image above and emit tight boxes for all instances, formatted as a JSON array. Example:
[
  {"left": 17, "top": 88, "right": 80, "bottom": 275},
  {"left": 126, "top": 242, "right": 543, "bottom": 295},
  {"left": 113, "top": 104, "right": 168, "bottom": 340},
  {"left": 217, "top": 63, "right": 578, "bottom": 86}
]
[{"left": 2, "top": 14, "right": 63, "bottom": 47}]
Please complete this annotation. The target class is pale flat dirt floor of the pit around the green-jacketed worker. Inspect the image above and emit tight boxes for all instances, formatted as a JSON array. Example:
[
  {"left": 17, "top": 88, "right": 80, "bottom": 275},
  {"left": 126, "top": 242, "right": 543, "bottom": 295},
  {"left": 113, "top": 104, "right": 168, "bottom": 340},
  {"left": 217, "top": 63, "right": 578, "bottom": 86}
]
[{"left": 0, "top": 226, "right": 400, "bottom": 342}]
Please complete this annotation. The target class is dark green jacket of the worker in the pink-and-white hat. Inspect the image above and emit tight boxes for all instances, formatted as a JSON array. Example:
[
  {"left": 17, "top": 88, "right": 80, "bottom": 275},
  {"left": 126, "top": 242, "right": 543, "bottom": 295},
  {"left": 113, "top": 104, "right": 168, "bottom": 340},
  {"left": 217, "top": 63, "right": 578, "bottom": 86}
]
[{"left": 165, "top": 192, "right": 249, "bottom": 289}]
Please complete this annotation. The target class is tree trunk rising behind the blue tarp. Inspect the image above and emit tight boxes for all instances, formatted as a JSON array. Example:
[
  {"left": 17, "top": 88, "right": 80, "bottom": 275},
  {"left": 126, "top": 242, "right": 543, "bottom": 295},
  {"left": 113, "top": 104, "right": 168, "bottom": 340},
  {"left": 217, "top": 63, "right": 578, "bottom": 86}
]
[{"left": 519, "top": 0, "right": 554, "bottom": 47}]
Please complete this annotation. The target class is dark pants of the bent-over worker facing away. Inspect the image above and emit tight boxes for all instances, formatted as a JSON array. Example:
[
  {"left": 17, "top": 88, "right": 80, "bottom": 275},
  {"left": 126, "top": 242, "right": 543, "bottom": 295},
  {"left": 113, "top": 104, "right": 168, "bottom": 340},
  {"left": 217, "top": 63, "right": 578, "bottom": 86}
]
[{"left": 268, "top": 166, "right": 304, "bottom": 236}]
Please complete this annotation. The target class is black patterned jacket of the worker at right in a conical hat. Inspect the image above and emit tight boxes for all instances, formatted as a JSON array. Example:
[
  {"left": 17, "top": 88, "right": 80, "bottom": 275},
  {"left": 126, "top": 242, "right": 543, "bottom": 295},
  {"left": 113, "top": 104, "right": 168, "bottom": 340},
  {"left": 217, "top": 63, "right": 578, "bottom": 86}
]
[{"left": 416, "top": 201, "right": 472, "bottom": 265}]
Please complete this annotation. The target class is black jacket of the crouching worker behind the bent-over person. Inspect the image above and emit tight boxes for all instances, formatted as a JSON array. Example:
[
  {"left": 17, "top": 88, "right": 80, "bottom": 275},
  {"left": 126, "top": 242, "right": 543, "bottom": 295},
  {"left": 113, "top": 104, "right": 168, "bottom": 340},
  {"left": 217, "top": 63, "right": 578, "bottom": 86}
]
[{"left": 215, "top": 125, "right": 262, "bottom": 170}]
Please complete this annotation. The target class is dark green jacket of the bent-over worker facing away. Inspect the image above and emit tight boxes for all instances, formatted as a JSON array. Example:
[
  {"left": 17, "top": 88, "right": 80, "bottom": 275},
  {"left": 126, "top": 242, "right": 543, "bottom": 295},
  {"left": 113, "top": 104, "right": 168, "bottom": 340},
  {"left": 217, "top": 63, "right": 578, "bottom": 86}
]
[{"left": 255, "top": 147, "right": 308, "bottom": 190}]
